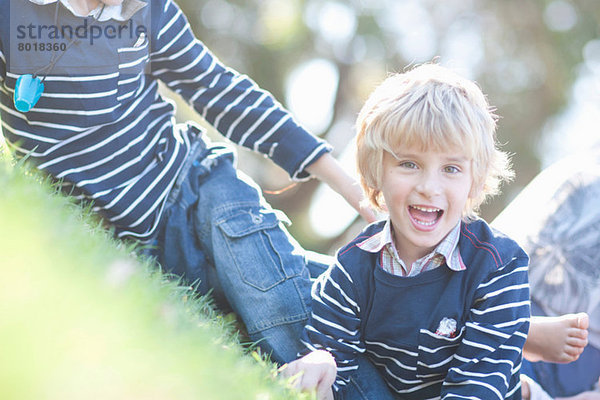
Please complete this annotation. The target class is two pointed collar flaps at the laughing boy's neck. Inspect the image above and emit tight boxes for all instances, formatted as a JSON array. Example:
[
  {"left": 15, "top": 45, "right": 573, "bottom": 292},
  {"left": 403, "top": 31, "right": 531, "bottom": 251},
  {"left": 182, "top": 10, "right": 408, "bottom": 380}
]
[{"left": 357, "top": 218, "right": 465, "bottom": 271}]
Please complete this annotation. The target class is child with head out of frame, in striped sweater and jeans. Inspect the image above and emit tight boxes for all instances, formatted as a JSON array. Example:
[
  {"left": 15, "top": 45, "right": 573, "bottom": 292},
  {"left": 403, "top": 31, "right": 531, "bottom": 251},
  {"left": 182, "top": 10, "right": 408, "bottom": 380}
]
[{"left": 0, "top": 0, "right": 370, "bottom": 362}]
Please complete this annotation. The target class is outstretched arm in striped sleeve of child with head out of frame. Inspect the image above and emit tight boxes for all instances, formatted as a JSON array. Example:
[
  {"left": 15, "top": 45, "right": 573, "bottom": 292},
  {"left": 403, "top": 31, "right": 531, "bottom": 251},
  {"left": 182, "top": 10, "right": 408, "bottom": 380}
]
[{"left": 150, "top": 0, "right": 375, "bottom": 222}]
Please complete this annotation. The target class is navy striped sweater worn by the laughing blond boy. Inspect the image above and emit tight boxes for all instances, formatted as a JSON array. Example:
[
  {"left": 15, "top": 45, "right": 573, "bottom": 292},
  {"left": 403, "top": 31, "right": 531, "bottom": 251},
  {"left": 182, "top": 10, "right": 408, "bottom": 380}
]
[{"left": 303, "top": 220, "right": 529, "bottom": 400}]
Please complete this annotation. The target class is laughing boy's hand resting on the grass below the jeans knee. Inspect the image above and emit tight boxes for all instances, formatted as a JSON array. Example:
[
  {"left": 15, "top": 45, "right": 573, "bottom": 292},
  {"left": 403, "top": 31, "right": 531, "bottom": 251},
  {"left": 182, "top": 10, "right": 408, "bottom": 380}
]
[{"left": 279, "top": 350, "right": 337, "bottom": 400}]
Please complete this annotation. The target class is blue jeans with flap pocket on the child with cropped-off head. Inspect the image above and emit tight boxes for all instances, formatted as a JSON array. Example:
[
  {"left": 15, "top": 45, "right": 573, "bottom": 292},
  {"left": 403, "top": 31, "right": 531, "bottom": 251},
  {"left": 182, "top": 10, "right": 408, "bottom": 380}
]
[{"left": 155, "top": 133, "right": 329, "bottom": 363}]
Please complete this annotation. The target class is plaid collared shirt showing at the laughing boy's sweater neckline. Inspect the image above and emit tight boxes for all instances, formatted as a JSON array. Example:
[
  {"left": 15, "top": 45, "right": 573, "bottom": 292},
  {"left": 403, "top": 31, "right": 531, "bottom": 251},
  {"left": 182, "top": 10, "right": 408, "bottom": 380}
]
[{"left": 358, "top": 219, "right": 466, "bottom": 276}]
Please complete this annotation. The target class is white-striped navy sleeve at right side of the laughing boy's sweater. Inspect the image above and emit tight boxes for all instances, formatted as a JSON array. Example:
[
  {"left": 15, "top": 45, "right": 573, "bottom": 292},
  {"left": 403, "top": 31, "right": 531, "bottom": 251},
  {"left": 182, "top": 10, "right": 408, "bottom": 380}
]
[{"left": 441, "top": 256, "right": 530, "bottom": 400}]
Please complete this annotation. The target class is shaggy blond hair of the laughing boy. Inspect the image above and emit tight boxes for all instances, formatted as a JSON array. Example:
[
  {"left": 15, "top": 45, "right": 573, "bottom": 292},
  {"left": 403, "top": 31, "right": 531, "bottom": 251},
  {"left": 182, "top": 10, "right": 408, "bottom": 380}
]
[{"left": 356, "top": 64, "right": 513, "bottom": 220}]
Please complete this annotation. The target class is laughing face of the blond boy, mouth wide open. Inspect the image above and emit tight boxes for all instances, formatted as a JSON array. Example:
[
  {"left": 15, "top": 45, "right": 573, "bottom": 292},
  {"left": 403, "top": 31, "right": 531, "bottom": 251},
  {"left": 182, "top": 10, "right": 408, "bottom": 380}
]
[{"left": 379, "top": 147, "right": 477, "bottom": 268}]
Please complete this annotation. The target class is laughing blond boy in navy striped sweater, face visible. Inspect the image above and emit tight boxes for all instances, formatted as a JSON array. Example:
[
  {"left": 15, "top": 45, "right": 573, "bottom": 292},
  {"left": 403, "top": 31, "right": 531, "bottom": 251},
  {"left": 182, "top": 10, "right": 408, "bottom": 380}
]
[{"left": 286, "top": 65, "right": 530, "bottom": 399}]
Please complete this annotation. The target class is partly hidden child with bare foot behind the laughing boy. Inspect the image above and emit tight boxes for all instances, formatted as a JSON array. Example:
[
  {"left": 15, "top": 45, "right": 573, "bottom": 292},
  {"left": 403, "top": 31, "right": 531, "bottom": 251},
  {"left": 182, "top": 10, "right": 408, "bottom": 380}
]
[{"left": 492, "top": 151, "right": 600, "bottom": 400}]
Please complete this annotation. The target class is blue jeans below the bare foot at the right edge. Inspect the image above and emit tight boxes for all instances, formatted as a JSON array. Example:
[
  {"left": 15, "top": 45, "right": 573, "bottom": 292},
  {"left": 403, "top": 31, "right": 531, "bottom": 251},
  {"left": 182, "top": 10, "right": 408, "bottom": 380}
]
[{"left": 521, "top": 301, "right": 600, "bottom": 397}]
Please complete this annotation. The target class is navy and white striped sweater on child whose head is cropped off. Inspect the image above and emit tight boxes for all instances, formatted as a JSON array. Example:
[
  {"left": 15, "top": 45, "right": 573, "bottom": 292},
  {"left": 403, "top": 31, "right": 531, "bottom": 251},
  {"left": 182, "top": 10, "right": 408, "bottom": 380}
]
[{"left": 0, "top": 0, "right": 329, "bottom": 241}]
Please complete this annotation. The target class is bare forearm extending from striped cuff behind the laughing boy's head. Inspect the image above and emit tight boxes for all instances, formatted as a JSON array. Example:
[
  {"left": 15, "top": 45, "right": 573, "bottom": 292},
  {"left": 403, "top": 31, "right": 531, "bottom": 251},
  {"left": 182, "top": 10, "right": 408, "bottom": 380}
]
[{"left": 306, "top": 153, "right": 377, "bottom": 223}]
